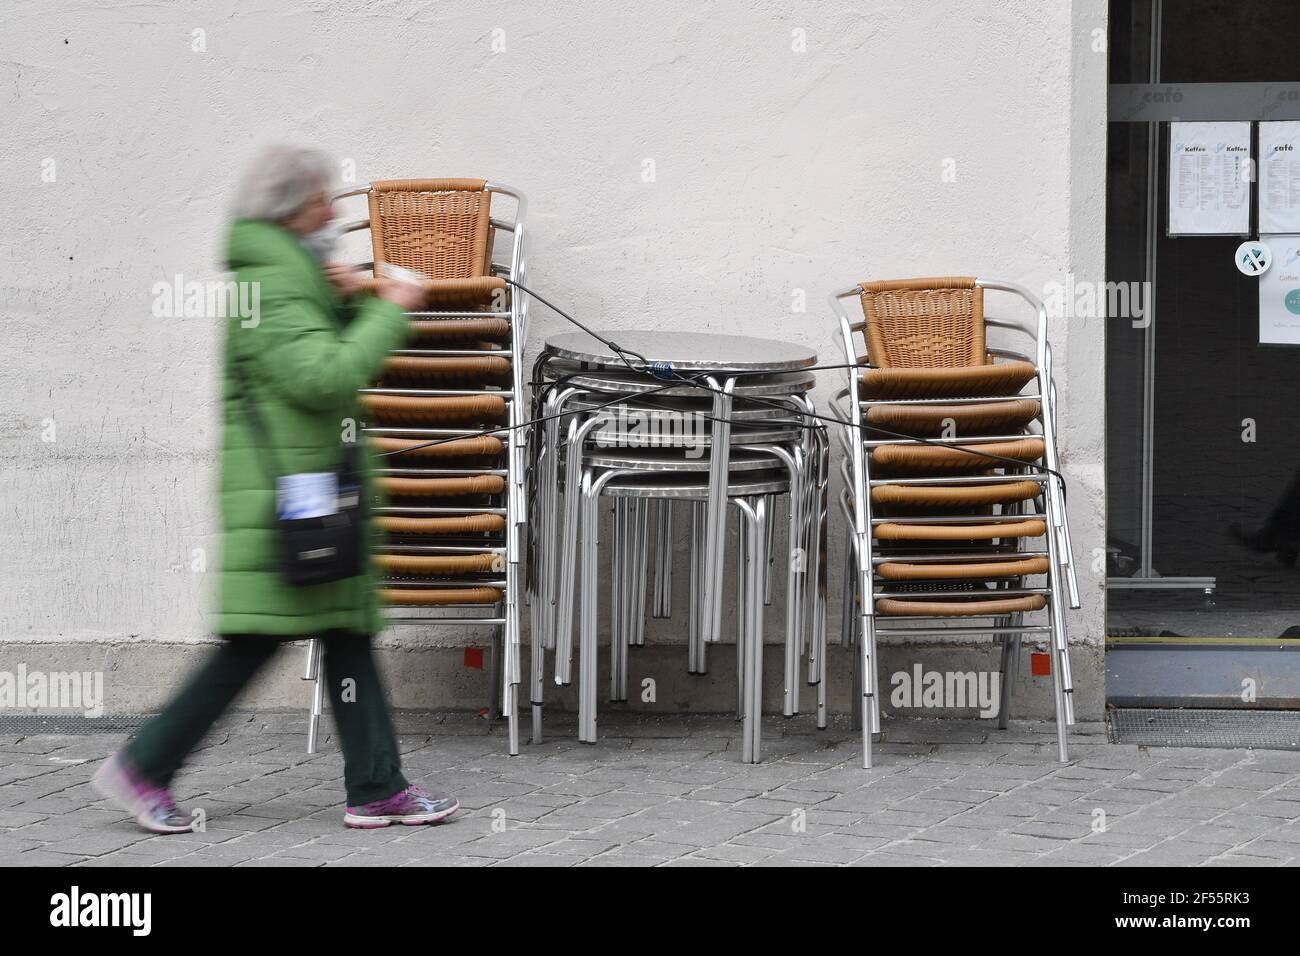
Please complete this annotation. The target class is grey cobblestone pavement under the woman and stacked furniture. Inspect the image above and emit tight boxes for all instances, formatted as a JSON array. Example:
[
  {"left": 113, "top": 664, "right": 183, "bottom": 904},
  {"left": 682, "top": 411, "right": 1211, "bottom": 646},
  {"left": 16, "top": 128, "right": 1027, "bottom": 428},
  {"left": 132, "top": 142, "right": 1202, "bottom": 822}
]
[{"left": 0, "top": 713, "right": 1300, "bottom": 866}]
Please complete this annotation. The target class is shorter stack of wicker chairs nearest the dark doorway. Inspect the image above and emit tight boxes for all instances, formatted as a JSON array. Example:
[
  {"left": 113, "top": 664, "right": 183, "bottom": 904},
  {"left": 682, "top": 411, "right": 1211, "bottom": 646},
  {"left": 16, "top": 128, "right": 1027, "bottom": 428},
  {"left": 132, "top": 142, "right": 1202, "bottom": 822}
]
[{"left": 832, "top": 277, "right": 1078, "bottom": 766}]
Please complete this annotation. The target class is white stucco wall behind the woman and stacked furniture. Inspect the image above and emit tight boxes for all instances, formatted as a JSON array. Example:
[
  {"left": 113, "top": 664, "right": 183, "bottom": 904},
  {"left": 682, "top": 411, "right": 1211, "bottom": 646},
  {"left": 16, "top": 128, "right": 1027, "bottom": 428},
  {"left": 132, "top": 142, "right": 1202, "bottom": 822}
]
[{"left": 0, "top": 0, "right": 1106, "bottom": 679}]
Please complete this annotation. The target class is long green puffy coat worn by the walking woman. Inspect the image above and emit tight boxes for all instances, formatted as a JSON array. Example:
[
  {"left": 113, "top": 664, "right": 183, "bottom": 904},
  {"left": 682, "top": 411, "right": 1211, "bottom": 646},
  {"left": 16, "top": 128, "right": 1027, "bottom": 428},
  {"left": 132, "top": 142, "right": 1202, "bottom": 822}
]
[{"left": 215, "top": 220, "right": 408, "bottom": 636}]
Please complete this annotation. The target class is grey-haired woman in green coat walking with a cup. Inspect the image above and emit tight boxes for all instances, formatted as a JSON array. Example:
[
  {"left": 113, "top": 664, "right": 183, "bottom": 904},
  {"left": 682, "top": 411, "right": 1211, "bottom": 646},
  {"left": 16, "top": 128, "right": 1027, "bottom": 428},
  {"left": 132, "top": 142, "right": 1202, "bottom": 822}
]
[{"left": 94, "top": 147, "right": 459, "bottom": 834}]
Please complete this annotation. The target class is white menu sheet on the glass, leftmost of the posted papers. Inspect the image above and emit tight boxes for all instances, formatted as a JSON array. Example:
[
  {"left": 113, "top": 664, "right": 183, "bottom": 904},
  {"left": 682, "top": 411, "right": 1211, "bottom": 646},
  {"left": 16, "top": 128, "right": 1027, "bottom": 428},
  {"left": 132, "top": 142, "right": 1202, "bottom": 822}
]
[{"left": 1169, "top": 122, "right": 1251, "bottom": 235}]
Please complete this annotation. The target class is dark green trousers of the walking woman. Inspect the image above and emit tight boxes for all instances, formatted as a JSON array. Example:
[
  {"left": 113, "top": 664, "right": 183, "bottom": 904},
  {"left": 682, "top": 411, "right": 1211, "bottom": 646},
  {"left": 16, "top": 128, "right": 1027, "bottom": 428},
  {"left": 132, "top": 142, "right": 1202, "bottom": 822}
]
[{"left": 126, "top": 631, "right": 408, "bottom": 806}]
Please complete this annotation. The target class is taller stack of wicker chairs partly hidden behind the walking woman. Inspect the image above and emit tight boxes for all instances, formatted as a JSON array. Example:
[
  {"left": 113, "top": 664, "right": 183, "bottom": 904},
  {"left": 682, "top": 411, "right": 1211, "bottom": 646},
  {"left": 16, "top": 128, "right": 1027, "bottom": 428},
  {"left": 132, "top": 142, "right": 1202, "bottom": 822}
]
[{"left": 299, "top": 179, "right": 527, "bottom": 753}]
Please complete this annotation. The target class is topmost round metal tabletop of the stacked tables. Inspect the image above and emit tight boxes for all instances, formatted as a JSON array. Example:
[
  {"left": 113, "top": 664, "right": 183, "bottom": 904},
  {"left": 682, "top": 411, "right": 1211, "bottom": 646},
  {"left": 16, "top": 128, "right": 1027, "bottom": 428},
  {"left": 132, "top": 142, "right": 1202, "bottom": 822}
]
[{"left": 546, "top": 329, "right": 816, "bottom": 372}]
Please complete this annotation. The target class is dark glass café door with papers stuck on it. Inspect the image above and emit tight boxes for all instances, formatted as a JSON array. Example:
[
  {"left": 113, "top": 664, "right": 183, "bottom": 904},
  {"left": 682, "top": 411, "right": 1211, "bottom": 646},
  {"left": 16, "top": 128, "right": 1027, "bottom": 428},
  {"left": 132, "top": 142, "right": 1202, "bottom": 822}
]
[{"left": 1106, "top": 0, "right": 1300, "bottom": 680}]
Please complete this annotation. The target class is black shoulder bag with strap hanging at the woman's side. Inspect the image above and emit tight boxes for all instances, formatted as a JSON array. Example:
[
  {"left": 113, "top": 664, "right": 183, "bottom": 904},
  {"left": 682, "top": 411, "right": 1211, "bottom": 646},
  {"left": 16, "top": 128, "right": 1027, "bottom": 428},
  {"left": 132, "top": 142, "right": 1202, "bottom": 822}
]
[{"left": 231, "top": 358, "right": 369, "bottom": 587}]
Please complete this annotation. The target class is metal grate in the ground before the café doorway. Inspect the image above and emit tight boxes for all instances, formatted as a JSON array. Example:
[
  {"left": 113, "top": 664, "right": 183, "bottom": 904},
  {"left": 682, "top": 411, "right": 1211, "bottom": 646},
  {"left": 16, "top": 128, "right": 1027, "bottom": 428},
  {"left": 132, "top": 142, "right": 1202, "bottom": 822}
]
[{"left": 1106, "top": 708, "right": 1300, "bottom": 750}]
